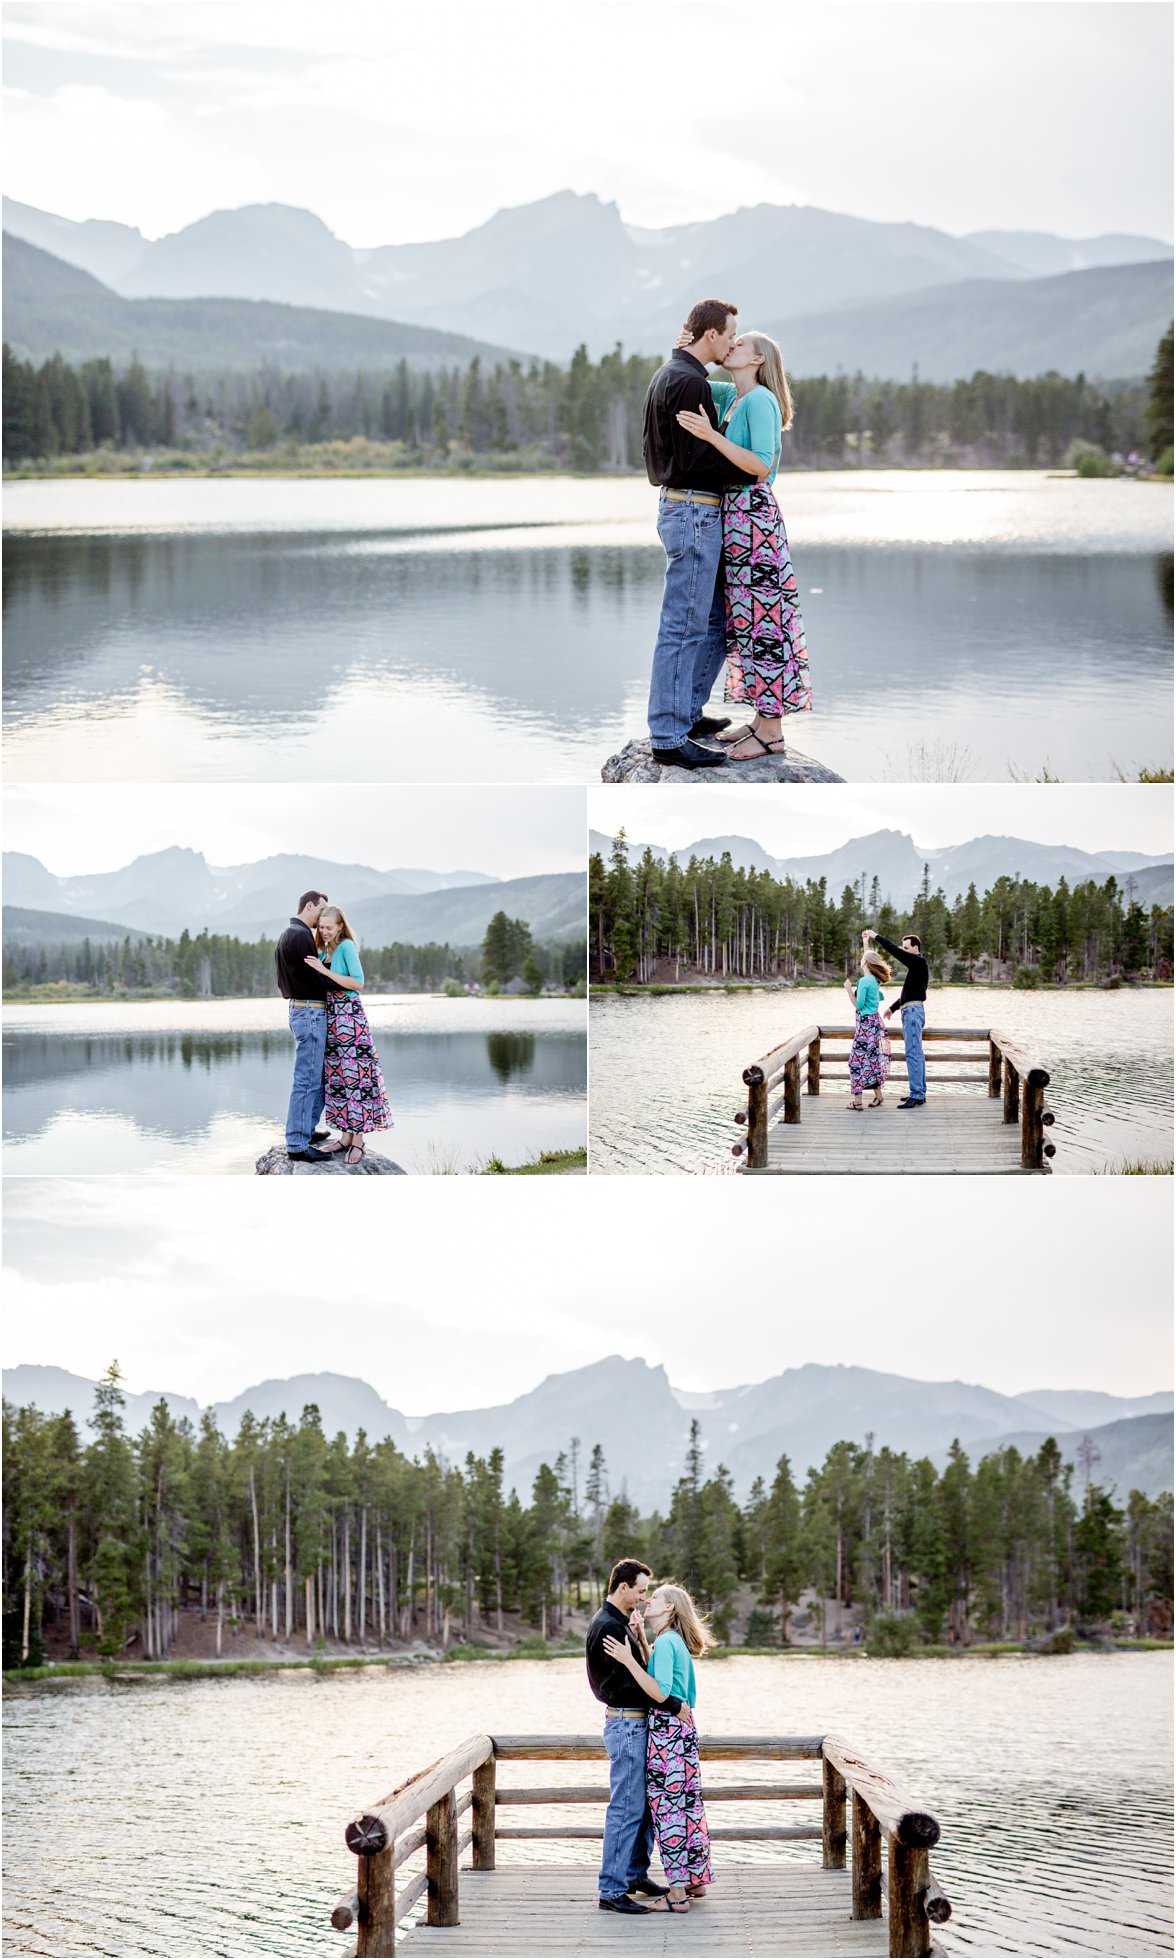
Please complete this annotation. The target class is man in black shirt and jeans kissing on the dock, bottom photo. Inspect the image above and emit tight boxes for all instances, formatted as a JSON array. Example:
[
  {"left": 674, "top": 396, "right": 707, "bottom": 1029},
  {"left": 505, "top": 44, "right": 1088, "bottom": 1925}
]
[{"left": 584, "top": 1558, "right": 682, "bottom": 1913}]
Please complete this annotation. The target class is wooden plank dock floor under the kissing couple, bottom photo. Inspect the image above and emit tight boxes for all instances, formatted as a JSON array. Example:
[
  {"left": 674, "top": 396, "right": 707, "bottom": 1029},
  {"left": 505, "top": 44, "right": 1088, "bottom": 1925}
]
[{"left": 396, "top": 1864, "right": 905, "bottom": 1960}]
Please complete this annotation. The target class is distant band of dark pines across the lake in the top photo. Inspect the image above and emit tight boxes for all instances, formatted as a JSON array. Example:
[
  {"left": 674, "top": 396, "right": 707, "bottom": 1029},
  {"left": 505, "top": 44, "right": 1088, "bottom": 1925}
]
[{"left": 4, "top": 341, "right": 1172, "bottom": 472}]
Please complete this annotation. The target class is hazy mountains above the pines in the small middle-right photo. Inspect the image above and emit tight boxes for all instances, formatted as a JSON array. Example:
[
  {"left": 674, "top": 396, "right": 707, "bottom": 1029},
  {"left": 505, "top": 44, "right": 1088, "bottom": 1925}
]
[{"left": 588, "top": 831, "right": 1172, "bottom": 907}]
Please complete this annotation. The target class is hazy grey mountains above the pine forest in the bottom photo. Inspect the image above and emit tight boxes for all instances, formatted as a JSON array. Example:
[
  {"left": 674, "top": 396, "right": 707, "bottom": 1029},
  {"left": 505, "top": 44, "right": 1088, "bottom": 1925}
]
[{"left": 4, "top": 1354, "right": 1172, "bottom": 1509}]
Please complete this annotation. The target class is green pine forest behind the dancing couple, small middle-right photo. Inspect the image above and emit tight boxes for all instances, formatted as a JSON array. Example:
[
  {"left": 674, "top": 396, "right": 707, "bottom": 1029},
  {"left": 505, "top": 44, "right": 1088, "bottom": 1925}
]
[{"left": 588, "top": 831, "right": 1172, "bottom": 986}]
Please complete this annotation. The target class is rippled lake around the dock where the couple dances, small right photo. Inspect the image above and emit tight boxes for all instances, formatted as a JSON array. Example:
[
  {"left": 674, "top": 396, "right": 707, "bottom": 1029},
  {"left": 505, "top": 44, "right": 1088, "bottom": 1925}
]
[{"left": 590, "top": 986, "right": 1172, "bottom": 1174}]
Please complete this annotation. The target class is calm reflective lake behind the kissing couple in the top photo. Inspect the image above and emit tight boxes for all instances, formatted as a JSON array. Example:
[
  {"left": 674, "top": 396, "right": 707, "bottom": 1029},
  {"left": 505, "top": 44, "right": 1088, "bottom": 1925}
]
[{"left": 4, "top": 470, "right": 1172, "bottom": 782}]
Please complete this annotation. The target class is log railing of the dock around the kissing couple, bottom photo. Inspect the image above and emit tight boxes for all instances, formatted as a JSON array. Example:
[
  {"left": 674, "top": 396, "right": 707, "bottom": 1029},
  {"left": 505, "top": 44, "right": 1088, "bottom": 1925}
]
[{"left": 331, "top": 1735, "right": 951, "bottom": 1956}]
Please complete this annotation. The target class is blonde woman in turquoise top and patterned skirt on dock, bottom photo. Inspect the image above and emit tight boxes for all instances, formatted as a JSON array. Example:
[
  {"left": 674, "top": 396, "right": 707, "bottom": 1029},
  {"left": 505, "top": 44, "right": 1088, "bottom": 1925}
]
[{"left": 604, "top": 1580, "right": 715, "bottom": 1913}]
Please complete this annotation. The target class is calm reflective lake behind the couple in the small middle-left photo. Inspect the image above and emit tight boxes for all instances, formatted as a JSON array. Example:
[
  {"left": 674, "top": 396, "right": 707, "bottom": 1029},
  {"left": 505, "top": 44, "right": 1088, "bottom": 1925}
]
[{"left": 4, "top": 994, "right": 586, "bottom": 1174}]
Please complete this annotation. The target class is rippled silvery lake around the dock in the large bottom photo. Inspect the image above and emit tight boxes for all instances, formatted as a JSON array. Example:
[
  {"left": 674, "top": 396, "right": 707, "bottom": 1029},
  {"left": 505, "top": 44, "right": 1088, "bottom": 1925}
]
[{"left": 4, "top": 1654, "right": 1172, "bottom": 1960}]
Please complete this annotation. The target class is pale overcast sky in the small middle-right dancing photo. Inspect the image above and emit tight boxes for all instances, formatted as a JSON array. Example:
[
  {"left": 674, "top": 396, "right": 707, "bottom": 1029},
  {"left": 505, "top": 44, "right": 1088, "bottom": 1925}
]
[{"left": 588, "top": 782, "right": 1172, "bottom": 857}]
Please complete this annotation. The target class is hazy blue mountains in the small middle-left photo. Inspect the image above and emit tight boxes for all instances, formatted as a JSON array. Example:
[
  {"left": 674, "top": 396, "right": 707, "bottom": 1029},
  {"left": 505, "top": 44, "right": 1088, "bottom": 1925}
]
[{"left": 4, "top": 845, "right": 584, "bottom": 947}]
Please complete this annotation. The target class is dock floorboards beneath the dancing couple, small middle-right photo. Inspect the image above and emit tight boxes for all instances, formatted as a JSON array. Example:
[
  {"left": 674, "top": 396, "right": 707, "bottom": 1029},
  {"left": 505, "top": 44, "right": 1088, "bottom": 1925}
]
[{"left": 743, "top": 1082, "right": 1031, "bottom": 1178}]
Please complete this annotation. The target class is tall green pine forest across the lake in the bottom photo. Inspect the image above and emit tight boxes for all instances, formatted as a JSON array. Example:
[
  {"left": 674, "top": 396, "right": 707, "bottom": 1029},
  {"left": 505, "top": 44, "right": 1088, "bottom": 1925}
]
[{"left": 4, "top": 1364, "right": 1172, "bottom": 1666}]
